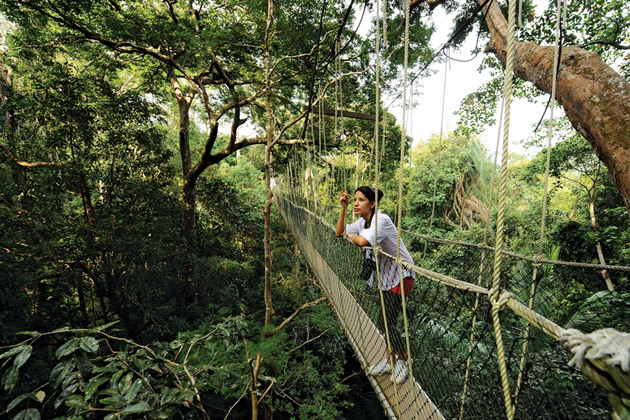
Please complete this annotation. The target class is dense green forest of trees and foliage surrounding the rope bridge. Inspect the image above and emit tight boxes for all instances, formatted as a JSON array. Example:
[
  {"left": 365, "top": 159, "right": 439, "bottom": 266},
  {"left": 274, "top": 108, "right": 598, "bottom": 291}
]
[{"left": 0, "top": 0, "right": 630, "bottom": 419}]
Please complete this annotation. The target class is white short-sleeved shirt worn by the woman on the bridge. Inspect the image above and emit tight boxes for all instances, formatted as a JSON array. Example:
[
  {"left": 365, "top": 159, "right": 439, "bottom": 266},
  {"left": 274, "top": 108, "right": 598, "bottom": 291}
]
[{"left": 346, "top": 210, "right": 416, "bottom": 290}]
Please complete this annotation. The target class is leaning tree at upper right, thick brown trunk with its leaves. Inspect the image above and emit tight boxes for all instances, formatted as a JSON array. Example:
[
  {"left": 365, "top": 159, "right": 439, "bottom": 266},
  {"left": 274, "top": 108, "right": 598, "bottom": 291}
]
[{"left": 424, "top": 0, "right": 630, "bottom": 215}]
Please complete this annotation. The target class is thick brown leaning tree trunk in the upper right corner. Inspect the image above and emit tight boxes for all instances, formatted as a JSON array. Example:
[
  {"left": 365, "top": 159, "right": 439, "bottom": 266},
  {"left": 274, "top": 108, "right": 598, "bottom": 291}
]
[{"left": 477, "top": 0, "right": 630, "bottom": 217}]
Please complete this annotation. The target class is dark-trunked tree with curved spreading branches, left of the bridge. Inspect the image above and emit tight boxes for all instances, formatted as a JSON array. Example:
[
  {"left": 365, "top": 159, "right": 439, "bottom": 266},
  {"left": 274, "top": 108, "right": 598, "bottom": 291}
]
[{"left": 0, "top": 0, "right": 350, "bottom": 266}]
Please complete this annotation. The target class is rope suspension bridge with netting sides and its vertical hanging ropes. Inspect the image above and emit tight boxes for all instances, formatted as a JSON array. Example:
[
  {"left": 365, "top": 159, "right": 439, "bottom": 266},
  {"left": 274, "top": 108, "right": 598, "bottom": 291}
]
[{"left": 274, "top": 0, "right": 630, "bottom": 420}]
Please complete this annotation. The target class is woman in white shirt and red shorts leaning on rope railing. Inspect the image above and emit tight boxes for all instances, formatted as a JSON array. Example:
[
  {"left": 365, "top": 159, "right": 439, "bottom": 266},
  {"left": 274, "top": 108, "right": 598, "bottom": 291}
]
[{"left": 336, "top": 187, "right": 415, "bottom": 384}]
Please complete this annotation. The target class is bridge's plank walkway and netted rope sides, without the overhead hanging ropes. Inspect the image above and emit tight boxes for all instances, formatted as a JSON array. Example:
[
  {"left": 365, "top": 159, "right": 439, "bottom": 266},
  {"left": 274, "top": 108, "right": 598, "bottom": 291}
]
[{"left": 274, "top": 193, "right": 630, "bottom": 420}]
